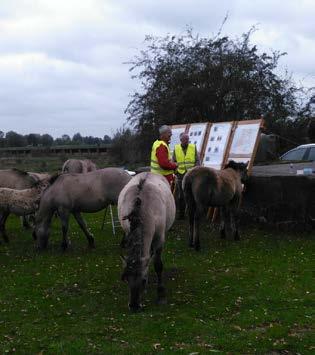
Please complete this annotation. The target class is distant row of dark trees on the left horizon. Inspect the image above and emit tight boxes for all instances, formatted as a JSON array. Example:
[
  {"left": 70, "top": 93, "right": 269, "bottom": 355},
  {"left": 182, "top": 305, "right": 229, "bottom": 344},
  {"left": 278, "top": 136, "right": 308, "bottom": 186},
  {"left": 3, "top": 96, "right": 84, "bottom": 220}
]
[{"left": 0, "top": 131, "right": 112, "bottom": 148}]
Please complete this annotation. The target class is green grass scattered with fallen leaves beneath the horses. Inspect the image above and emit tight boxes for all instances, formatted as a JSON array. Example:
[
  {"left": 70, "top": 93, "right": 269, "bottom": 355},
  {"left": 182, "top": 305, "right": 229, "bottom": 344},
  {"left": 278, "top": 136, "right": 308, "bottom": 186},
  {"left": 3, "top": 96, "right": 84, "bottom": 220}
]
[{"left": 0, "top": 213, "right": 315, "bottom": 354}]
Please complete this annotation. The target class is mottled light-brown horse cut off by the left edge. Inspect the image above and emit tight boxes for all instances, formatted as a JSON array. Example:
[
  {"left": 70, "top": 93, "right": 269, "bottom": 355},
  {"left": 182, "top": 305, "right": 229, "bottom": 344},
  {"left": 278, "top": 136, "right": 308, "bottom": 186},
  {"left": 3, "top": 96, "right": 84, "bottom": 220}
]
[{"left": 0, "top": 177, "right": 54, "bottom": 242}]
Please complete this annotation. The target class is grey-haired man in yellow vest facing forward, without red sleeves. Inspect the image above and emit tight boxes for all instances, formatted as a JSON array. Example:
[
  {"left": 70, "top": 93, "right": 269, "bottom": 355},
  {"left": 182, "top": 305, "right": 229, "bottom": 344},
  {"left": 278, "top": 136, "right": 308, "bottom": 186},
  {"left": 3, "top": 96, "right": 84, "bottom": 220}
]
[{"left": 173, "top": 133, "right": 200, "bottom": 219}]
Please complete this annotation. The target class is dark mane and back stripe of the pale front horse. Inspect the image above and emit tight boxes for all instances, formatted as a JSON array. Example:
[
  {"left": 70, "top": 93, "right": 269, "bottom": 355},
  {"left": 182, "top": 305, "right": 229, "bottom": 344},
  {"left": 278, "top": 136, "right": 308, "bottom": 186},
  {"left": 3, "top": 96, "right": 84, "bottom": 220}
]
[{"left": 123, "top": 177, "right": 146, "bottom": 274}]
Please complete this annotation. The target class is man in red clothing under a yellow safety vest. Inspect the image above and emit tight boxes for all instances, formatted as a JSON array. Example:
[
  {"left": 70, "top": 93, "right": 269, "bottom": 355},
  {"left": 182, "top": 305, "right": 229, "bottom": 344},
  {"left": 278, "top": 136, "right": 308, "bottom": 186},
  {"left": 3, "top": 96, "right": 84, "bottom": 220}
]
[{"left": 151, "top": 125, "right": 177, "bottom": 186}]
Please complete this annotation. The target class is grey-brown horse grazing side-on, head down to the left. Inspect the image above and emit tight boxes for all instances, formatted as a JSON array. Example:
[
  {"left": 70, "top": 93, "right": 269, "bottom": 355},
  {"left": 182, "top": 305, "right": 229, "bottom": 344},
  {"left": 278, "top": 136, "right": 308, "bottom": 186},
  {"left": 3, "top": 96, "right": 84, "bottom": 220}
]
[{"left": 33, "top": 168, "right": 131, "bottom": 250}]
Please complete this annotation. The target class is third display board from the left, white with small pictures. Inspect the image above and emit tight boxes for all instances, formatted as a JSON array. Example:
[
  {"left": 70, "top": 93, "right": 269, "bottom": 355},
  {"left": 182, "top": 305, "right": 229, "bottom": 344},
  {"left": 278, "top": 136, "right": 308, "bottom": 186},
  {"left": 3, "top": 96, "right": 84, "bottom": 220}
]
[{"left": 202, "top": 122, "right": 233, "bottom": 170}]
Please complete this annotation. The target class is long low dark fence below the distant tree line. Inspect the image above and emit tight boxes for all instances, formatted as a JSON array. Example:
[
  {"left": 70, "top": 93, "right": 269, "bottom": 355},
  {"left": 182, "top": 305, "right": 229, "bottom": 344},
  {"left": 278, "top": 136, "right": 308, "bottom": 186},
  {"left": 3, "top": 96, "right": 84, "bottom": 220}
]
[{"left": 0, "top": 144, "right": 111, "bottom": 157}]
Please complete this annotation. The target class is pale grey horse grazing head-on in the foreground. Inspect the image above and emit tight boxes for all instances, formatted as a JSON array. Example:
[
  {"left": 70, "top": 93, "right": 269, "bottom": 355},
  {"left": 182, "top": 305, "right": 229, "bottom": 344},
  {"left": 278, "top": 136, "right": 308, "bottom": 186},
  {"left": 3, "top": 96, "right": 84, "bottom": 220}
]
[{"left": 118, "top": 172, "right": 176, "bottom": 311}]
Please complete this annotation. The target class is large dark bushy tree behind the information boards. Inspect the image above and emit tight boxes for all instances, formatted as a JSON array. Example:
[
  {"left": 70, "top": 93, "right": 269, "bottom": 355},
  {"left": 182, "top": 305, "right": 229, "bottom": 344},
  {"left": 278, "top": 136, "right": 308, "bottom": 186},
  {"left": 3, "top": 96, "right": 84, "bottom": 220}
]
[{"left": 126, "top": 29, "right": 312, "bottom": 152}]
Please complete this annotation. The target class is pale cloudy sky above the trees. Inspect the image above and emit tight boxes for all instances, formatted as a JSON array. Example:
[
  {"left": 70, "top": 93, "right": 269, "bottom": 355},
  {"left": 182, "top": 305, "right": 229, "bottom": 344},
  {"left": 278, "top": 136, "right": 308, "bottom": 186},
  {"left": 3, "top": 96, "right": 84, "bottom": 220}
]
[{"left": 0, "top": 0, "right": 315, "bottom": 138}]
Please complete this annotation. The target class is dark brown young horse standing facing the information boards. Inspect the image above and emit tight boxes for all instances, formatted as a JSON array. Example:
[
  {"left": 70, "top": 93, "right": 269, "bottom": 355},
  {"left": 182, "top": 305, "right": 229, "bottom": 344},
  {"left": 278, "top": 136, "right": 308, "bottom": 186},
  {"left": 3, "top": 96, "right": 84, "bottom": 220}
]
[{"left": 183, "top": 161, "right": 247, "bottom": 250}]
